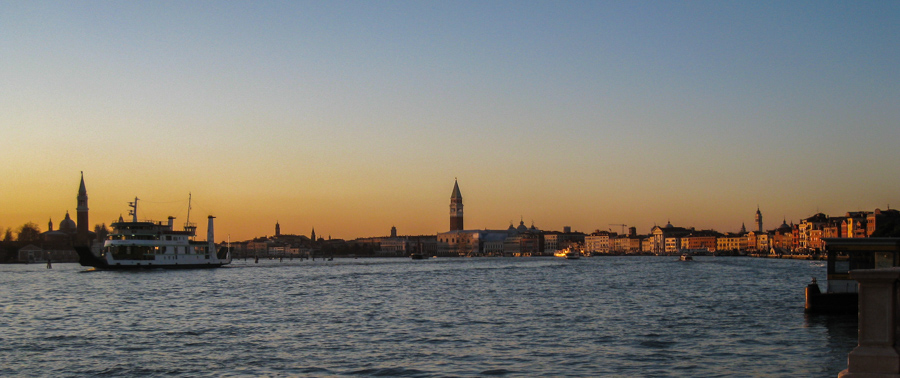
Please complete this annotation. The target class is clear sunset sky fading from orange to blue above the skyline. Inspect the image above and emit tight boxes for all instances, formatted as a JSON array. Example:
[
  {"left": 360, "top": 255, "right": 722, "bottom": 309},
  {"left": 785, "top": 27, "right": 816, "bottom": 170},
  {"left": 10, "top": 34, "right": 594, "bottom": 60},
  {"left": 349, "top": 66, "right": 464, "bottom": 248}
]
[{"left": 0, "top": 0, "right": 900, "bottom": 240}]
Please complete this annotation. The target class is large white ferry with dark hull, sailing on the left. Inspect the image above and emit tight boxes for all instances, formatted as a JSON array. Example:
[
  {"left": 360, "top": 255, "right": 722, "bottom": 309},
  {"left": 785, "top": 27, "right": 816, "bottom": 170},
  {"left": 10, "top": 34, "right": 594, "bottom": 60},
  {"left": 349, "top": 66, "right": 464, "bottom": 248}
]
[{"left": 75, "top": 198, "right": 231, "bottom": 270}]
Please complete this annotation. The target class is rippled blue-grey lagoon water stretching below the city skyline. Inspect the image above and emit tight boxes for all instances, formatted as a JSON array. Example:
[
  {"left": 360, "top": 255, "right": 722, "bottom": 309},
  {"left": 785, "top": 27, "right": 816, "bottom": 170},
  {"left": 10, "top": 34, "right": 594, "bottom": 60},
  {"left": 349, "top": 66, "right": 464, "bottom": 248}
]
[{"left": 0, "top": 257, "right": 856, "bottom": 377}]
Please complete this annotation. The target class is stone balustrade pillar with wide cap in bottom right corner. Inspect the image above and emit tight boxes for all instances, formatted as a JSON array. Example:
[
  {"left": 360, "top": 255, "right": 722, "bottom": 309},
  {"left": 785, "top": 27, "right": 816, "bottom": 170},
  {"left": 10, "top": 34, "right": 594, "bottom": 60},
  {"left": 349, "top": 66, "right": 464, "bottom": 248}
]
[{"left": 838, "top": 268, "right": 900, "bottom": 378}]
